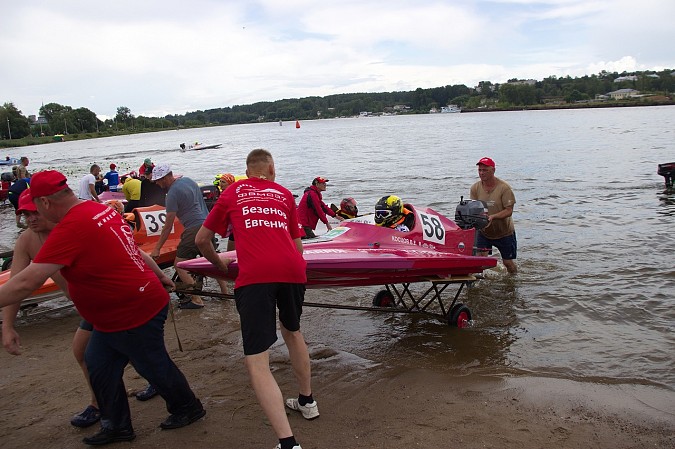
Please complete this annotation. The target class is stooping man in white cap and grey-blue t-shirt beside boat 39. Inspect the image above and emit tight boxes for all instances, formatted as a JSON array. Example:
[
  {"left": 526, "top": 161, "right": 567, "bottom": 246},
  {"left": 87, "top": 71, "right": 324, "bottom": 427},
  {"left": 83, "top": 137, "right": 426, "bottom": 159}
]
[{"left": 150, "top": 164, "right": 227, "bottom": 309}]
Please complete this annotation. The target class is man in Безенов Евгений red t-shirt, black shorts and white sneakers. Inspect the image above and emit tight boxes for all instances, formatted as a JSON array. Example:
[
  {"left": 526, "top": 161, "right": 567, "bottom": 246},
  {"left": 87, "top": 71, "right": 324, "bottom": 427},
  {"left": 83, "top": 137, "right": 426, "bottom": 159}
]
[{"left": 195, "top": 149, "right": 319, "bottom": 449}]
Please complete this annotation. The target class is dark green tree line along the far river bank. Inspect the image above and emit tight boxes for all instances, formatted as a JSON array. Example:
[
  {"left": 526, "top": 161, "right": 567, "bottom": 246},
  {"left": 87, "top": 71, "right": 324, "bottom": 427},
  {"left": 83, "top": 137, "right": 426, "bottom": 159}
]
[{"left": 0, "top": 69, "right": 675, "bottom": 139}]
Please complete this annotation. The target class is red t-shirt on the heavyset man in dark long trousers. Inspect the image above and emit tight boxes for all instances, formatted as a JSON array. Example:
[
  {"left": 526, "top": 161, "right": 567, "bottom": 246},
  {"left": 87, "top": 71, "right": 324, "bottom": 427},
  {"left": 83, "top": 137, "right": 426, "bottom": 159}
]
[{"left": 34, "top": 201, "right": 169, "bottom": 332}]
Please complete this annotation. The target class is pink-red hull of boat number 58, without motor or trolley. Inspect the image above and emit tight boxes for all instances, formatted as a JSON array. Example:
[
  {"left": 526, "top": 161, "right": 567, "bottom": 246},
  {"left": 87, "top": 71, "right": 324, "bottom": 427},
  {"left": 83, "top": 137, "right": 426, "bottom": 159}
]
[{"left": 178, "top": 205, "right": 497, "bottom": 287}]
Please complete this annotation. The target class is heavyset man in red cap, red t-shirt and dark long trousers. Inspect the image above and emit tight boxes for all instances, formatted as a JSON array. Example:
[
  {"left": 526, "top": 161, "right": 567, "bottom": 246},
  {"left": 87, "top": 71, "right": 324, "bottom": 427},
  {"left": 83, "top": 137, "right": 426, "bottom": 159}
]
[{"left": 0, "top": 170, "right": 206, "bottom": 445}]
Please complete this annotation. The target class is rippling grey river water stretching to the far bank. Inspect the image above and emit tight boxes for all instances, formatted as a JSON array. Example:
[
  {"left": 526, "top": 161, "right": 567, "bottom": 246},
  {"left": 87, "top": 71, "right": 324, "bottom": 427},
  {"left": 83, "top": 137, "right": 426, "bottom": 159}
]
[{"left": 0, "top": 106, "right": 675, "bottom": 390}]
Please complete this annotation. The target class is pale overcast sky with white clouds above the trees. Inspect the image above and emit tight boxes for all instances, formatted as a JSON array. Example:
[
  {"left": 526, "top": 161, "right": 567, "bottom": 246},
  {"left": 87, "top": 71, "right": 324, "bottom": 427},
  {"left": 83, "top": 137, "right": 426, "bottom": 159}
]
[{"left": 0, "top": 0, "right": 675, "bottom": 117}]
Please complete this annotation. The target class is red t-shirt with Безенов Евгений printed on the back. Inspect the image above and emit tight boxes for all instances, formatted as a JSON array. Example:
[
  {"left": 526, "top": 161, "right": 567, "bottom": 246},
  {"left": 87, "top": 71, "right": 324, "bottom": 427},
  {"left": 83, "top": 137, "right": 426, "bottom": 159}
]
[{"left": 204, "top": 178, "right": 307, "bottom": 287}]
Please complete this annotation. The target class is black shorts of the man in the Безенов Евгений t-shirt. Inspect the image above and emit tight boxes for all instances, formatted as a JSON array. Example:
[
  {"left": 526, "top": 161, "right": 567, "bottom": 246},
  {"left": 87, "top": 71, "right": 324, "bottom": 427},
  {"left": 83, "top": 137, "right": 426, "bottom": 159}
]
[{"left": 234, "top": 282, "right": 305, "bottom": 355}]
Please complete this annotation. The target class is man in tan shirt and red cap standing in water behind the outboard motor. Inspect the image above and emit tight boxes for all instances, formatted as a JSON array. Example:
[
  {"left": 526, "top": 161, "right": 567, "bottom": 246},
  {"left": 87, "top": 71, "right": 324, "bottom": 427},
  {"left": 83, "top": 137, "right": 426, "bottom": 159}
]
[{"left": 471, "top": 157, "right": 518, "bottom": 274}]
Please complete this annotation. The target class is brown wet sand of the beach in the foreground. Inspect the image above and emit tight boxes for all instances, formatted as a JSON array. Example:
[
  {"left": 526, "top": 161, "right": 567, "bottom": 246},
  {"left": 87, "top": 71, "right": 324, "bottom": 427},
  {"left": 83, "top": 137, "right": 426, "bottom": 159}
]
[{"left": 0, "top": 291, "right": 675, "bottom": 449}]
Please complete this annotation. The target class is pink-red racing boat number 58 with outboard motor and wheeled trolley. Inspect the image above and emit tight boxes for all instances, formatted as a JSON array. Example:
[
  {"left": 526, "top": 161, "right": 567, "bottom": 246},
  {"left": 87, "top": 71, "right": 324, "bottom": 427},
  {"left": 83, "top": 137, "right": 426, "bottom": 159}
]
[{"left": 178, "top": 200, "right": 497, "bottom": 327}]
